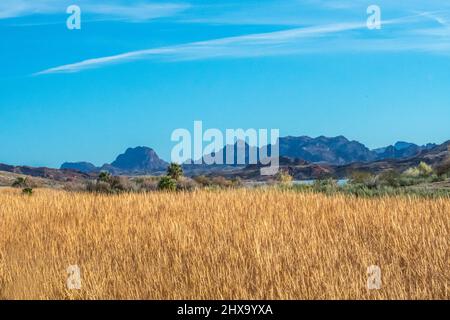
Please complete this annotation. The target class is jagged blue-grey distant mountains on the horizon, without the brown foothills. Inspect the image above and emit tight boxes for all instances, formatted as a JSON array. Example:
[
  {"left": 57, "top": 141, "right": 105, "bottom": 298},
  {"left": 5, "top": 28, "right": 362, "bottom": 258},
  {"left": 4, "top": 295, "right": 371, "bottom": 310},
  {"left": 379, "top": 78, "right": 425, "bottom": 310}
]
[{"left": 61, "top": 136, "right": 437, "bottom": 175}]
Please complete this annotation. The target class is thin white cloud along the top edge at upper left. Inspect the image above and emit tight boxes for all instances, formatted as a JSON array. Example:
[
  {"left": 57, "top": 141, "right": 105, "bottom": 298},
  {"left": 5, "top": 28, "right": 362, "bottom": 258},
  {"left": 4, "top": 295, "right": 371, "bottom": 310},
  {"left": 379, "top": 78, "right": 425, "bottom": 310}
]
[{"left": 0, "top": 0, "right": 190, "bottom": 21}]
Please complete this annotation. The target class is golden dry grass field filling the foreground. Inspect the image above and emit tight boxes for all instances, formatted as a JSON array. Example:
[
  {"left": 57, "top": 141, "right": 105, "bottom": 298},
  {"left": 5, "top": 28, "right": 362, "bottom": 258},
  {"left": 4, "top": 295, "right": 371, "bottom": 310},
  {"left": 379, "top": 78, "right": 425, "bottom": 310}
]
[{"left": 0, "top": 189, "right": 450, "bottom": 299}]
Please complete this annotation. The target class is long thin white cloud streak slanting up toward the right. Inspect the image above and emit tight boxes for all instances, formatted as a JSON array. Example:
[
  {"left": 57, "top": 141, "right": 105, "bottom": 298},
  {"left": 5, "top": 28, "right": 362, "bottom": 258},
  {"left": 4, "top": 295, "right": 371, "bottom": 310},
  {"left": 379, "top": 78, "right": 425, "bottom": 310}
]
[{"left": 34, "top": 13, "right": 450, "bottom": 75}]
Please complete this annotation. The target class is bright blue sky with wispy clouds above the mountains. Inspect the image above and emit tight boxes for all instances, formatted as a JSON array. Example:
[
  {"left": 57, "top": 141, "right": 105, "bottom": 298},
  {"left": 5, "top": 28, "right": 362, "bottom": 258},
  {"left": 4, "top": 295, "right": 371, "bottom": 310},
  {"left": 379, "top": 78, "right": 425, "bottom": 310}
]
[{"left": 0, "top": 0, "right": 450, "bottom": 167}]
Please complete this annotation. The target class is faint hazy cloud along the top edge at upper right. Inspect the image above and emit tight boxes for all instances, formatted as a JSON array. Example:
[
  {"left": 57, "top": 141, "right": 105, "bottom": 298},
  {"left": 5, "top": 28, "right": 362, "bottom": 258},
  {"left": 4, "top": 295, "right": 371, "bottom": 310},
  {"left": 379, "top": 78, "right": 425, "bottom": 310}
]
[{"left": 181, "top": 0, "right": 450, "bottom": 26}]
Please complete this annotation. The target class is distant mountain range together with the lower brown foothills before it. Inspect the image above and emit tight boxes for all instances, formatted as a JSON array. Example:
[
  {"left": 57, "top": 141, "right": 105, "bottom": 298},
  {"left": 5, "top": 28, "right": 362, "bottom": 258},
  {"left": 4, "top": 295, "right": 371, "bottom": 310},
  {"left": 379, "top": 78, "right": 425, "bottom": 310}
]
[{"left": 0, "top": 136, "right": 450, "bottom": 182}]
